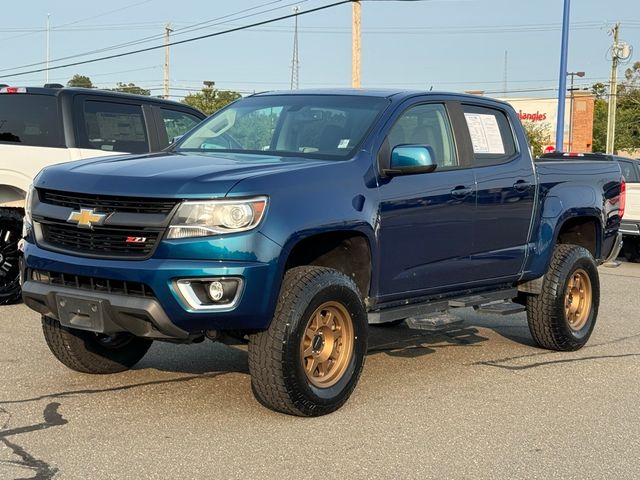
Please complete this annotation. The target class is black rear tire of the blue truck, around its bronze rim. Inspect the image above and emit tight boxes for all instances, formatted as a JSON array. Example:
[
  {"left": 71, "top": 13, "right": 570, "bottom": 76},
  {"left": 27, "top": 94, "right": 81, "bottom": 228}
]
[{"left": 527, "top": 244, "right": 600, "bottom": 351}]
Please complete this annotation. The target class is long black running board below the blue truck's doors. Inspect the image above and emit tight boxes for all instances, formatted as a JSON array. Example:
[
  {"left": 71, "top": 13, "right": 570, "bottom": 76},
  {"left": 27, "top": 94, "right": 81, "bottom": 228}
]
[{"left": 368, "top": 288, "right": 522, "bottom": 324}]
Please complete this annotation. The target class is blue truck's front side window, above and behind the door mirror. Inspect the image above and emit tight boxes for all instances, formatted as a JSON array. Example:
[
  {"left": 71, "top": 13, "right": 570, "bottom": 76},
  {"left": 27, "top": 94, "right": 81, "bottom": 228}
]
[{"left": 387, "top": 103, "right": 458, "bottom": 170}]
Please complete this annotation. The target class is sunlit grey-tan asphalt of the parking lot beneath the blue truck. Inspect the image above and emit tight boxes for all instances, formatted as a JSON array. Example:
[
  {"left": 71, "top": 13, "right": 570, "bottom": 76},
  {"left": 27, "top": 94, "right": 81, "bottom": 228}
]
[{"left": 0, "top": 263, "right": 640, "bottom": 480}]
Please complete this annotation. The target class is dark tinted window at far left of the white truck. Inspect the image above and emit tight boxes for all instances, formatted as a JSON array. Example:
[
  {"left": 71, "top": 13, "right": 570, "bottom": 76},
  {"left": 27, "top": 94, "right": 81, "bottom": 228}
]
[{"left": 0, "top": 93, "right": 64, "bottom": 147}]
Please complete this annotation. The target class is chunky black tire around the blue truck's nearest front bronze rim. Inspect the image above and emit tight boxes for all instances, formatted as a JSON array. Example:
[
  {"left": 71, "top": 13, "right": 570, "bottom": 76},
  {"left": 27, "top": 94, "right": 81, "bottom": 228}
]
[{"left": 249, "top": 266, "right": 367, "bottom": 417}]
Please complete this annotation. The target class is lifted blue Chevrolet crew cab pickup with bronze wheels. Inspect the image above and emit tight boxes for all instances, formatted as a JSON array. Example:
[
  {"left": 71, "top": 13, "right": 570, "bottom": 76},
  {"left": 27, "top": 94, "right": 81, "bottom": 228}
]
[{"left": 22, "top": 90, "right": 624, "bottom": 416}]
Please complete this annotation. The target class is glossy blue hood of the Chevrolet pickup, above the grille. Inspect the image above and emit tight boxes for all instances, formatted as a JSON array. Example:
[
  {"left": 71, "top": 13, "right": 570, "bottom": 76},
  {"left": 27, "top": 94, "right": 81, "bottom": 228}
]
[{"left": 34, "top": 152, "right": 332, "bottom": 198}]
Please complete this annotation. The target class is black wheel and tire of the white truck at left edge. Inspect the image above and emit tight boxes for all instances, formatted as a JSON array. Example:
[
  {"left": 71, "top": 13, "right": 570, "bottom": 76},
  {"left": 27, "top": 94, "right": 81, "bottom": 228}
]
[{"left": 0, "top": 208, "right": 24, "bottom": 305}]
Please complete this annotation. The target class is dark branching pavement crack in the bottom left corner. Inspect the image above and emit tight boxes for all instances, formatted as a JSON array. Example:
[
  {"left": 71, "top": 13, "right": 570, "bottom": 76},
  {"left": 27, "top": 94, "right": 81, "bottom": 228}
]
[{"left": 0, "top": 402, "right": 67, "bottom": 480}]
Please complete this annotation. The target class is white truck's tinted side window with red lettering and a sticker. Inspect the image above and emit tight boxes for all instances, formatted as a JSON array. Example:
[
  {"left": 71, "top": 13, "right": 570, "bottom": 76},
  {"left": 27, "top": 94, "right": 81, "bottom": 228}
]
[{"left": 80, "top": 100, "right": 149, "bottom": 153}]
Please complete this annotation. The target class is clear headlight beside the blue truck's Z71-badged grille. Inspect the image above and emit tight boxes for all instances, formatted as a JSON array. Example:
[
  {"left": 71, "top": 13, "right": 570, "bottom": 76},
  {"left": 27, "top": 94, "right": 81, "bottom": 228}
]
[{"left": 167, "top": 197, "right": 267, "bottom": 238}]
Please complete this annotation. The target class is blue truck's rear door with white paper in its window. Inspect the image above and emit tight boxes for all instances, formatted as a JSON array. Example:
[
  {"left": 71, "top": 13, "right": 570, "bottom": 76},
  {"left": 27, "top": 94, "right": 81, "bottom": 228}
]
[{"left": 457, "top": 104, "right": 536, "bottom": 281}]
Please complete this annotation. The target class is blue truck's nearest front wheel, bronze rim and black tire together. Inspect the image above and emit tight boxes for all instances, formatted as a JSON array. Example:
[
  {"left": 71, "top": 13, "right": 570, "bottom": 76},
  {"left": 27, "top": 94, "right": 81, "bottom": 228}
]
[{"left": 249, "top": 267, "right": 367, "bottom": 417}]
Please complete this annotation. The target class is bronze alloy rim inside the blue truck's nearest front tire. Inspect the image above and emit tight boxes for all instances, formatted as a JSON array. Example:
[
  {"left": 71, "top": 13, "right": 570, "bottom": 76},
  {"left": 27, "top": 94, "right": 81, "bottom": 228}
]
[{"left": 300, "top": 302, "right": 354, "bottom": 388}]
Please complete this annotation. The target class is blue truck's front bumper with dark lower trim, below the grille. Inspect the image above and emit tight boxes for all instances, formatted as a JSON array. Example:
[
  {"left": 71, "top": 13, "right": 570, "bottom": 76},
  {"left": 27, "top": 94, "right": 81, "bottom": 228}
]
[{"left": 23, "top": 241, "right": 280, "bottom": 339}]
